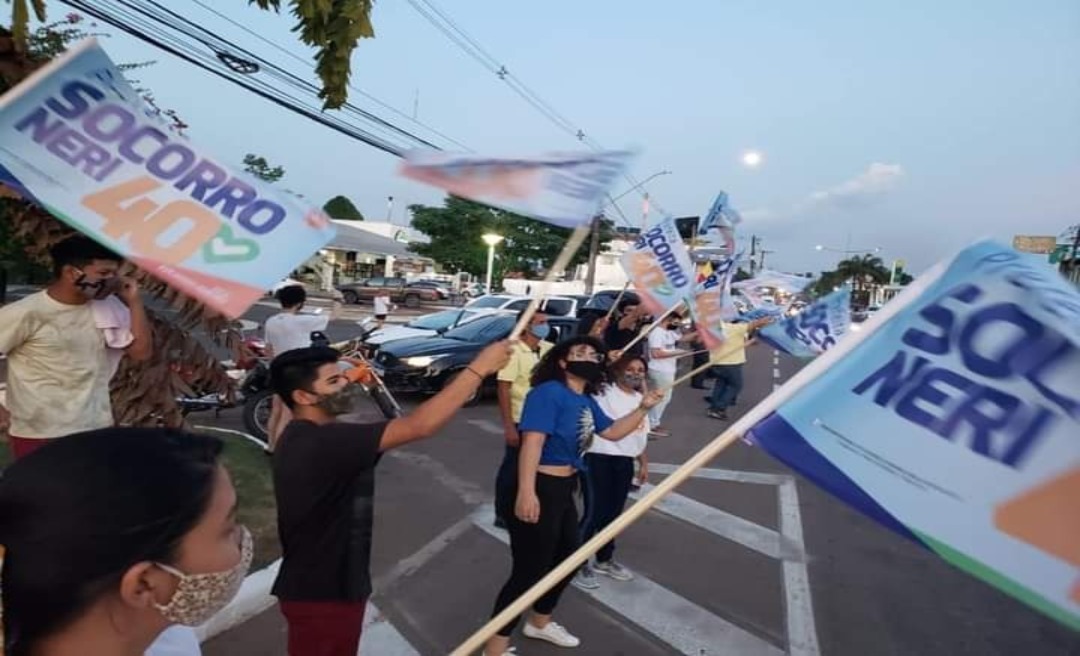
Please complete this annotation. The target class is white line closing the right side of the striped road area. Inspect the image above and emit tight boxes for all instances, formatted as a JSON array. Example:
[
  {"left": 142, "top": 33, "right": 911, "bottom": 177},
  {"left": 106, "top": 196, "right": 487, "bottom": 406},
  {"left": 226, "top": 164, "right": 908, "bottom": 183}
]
[{"left": 778, "top": 479, "right": 821, "bottom": 656}]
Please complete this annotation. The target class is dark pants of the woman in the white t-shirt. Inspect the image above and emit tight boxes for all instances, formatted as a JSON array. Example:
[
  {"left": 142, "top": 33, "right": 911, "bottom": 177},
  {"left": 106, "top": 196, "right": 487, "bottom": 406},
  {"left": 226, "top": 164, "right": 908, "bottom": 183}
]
[{"left": 580, "top": 453, "right": 634, "bottom": 563}]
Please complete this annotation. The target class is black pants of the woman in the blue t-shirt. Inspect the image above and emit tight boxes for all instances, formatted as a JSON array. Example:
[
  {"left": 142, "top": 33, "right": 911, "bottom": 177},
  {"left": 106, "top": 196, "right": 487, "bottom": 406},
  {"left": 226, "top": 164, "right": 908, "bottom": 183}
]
[{"left": 491, "top": 473, "right": 579, "bottom": 637}]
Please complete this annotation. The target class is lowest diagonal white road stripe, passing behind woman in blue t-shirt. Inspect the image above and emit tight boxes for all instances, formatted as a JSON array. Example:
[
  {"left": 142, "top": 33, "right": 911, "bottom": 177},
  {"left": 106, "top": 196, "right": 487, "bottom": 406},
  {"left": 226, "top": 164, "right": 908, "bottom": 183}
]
[{"left": 473, "top": 505, "right": 784, "bottom": 656}]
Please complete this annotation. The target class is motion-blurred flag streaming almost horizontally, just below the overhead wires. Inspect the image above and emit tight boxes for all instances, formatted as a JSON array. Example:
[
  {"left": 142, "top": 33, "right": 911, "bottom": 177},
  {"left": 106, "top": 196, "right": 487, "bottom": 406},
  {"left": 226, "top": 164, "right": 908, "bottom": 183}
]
[{"left": 401, "top": 150, "right": 634, "bottom": 228}]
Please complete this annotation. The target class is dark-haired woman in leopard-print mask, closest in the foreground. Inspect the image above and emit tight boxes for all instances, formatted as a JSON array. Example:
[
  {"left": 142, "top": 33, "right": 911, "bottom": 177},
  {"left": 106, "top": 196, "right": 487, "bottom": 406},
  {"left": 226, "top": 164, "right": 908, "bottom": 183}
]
[{"left": 0, "top": 428, "right": 252, "bottom": 656}]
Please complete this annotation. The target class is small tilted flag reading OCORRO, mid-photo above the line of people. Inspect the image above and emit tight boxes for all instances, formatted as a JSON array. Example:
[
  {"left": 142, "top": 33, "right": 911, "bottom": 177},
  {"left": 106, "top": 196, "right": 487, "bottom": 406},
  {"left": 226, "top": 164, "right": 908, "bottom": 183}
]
[{"left": 621, "top": 210, "right": 696, "bottom": 316}]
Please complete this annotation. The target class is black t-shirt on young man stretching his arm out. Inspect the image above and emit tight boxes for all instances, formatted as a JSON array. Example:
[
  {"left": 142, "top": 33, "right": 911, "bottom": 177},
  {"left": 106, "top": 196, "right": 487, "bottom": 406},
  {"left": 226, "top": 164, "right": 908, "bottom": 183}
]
[{"left": 272, "top": 420, "right": 387, "bottom": 602}]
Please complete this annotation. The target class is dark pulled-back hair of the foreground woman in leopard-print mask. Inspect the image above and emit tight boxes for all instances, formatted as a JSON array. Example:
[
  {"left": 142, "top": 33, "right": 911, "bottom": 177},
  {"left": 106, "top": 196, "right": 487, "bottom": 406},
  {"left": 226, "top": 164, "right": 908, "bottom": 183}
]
[{"left": 0, "top": 428, "right": 221, "bottom": 656}]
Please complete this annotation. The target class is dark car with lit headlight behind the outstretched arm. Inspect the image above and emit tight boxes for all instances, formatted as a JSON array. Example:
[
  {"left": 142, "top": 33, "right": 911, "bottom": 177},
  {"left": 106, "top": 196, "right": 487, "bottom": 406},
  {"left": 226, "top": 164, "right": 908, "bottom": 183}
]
[{"left": 374, "top": 311, "right": 578, "bottom": 403}]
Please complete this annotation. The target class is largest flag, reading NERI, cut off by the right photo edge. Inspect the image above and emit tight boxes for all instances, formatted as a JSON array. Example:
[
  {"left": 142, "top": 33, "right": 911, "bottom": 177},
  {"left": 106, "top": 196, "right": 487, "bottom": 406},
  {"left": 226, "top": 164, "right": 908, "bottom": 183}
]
[{"left": 751, "top": 241, "right": 1080, "bottom": 630}]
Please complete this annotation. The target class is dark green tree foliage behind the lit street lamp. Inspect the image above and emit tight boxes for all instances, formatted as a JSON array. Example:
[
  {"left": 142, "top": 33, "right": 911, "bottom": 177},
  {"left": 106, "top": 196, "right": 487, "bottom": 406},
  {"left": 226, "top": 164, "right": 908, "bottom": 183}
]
[{"left": 409, "top": 196, "right": 615, "bottom": 278}]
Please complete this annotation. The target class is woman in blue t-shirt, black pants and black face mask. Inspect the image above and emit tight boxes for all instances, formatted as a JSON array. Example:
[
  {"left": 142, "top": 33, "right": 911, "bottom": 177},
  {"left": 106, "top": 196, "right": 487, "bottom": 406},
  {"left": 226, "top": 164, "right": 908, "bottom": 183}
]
[{"left": 484, "top": 336, "right": 663, "bottom": 656}]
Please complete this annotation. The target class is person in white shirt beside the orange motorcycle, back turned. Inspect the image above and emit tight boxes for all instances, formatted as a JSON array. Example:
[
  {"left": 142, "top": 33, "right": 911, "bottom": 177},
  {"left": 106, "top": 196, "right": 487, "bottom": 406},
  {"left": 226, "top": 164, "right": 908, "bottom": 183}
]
[{"left": 262, "top": 284, "right": 341, "bottom": 453}]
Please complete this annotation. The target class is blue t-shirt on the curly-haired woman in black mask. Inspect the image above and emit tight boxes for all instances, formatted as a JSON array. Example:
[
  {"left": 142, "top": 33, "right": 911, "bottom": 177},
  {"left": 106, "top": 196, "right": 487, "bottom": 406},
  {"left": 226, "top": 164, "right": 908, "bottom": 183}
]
[{"left": 518, "top": 380, "right": 613, "bottom": 469}]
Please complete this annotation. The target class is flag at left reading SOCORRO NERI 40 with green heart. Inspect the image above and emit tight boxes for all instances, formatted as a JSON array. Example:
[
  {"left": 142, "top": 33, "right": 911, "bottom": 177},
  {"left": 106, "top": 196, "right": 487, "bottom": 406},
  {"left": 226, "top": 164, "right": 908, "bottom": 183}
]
[{"left": 0, "top": 39, "right": 335, "bottom": 318}]
